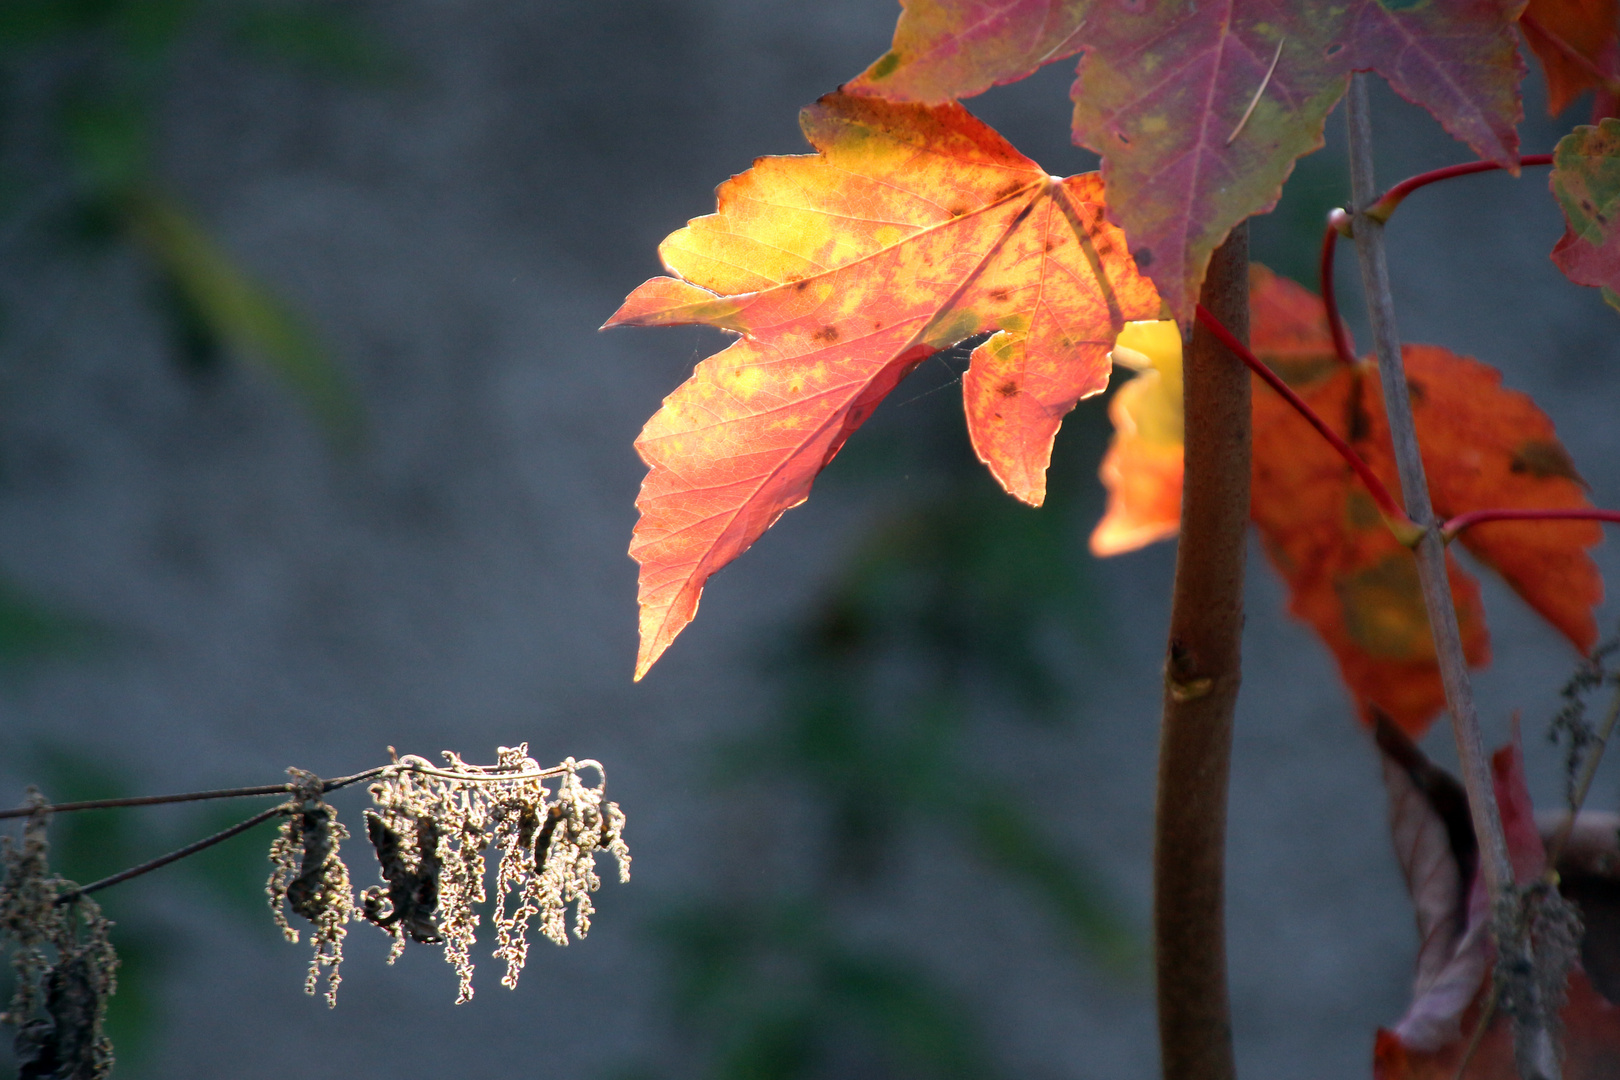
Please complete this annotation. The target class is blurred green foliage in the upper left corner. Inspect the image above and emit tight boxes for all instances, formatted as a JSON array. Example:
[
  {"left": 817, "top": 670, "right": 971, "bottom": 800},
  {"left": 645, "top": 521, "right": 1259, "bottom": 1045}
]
[{"left": 0, "top": 0, "right": 399, "bottom": 445}]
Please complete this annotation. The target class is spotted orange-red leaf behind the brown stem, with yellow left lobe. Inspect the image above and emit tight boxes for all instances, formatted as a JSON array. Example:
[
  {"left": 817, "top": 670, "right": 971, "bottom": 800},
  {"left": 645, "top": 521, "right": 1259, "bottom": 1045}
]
[{"left": 1092, "top": 267, "right": 1602, "bottom": 733}]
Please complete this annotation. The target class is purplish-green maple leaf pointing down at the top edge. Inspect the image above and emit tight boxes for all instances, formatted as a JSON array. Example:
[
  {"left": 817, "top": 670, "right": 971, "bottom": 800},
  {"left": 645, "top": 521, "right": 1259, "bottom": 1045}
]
[{"left": 849, "top": 0, "right": 1524, "bottom": 317}]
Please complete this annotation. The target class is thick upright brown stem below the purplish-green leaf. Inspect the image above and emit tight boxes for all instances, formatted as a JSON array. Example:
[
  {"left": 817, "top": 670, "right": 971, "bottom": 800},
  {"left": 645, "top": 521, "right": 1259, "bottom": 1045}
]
[{"left": 1153, "top": 225, "right": 1251, "bottom": 1080}]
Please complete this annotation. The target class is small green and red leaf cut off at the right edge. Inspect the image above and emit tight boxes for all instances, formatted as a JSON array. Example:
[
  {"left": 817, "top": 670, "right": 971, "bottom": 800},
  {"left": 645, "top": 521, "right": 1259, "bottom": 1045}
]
[{"left": 1547, "top": 120, "right": 1620, "bottom": 308}]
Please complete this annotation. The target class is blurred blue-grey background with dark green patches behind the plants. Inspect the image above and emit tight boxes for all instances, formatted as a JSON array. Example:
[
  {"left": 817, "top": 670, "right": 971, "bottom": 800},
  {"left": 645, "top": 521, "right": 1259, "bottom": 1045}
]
[{"left": 0, "top": 0, "right": 1620, "bottom": 1080}]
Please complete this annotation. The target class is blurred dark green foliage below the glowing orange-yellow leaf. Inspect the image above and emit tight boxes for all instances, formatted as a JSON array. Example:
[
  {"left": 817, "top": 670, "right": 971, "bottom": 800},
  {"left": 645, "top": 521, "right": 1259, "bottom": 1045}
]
[{"left": 631, "top": 350, "right": 1142, "bottom": 1080}]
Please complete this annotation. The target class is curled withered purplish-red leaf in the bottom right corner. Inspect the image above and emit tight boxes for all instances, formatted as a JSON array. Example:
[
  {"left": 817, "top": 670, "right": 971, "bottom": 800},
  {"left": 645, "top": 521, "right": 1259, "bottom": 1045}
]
[{"left": 1372, "top": 722, "right": 1620, "bottom": 1080}]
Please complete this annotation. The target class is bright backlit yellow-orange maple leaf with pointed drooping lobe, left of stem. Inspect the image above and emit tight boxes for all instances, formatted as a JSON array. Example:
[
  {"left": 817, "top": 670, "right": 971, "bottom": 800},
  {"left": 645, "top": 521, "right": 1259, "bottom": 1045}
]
[{"left": 608, "top": 94, "right": 1162, "bottom": 678}]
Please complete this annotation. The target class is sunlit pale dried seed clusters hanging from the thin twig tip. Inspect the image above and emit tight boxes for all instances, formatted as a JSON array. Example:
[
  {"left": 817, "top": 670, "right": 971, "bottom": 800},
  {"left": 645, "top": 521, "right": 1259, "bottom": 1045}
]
[{"left": 267, "top": 743, "right": 630, "bottom": 1004}]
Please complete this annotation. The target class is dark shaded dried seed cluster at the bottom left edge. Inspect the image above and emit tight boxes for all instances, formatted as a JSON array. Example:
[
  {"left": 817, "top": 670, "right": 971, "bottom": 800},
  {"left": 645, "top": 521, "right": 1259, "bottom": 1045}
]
[{"left": 0, "top": 790, "right": 118, "bottom": 1080}]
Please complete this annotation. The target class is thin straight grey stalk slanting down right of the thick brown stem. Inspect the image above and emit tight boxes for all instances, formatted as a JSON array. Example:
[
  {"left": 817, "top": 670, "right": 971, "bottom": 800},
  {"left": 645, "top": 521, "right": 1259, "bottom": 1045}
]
[{"left": 1348, "top": 74, "right": 1560, "bottom": 1080}]
